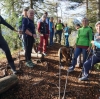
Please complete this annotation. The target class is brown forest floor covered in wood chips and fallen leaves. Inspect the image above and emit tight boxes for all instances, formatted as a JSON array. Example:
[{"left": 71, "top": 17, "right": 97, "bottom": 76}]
[{"left": 0, "top": 43, "right": 100, "bottom": 99}]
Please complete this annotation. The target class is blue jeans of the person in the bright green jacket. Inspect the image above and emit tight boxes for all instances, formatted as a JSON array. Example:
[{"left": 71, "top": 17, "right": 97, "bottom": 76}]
[{"left": 72, "top": 47, "right": 87, "bottom": 69}]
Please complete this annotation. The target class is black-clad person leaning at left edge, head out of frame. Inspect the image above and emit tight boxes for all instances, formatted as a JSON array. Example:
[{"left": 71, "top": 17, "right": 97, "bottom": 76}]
[{"left": 0, "top": 15, "right": 18, "bottom": 74}]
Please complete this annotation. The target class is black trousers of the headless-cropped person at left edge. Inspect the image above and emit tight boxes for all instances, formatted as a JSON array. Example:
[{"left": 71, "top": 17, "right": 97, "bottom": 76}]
[{"left": 0, "top": 34, "right": 16, "bottom": 70}]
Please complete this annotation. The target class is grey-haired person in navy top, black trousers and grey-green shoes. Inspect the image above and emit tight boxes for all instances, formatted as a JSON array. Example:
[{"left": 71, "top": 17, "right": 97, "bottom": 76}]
[{"left": 22, "top": 9, "right": 36, "bottom": 67}]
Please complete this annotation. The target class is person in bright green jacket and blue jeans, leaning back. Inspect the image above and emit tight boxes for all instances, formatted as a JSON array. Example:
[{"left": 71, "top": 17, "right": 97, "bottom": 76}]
[{"left": 68, "top": 18, "right": 92, "bottom": 72}]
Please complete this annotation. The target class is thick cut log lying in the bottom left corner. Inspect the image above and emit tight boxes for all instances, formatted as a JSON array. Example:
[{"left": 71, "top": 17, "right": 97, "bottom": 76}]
[{"left": 0, "top": 75, "right": 18, "bottom": 94}]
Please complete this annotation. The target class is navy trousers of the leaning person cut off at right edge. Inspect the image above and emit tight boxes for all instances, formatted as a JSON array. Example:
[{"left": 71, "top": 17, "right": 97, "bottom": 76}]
[{"left": 82, "top": 55, "right": 100, "bottom": 77}]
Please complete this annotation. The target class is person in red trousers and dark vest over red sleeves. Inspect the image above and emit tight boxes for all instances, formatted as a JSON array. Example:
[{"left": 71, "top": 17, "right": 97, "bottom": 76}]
[{"left": 37, "top": 15, "right": 49, "bottom": 56}]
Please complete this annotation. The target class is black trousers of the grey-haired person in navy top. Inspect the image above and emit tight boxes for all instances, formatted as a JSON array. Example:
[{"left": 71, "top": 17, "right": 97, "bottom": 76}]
[{"left": 24, "top": 36, "right": 34, "bottom": 61}]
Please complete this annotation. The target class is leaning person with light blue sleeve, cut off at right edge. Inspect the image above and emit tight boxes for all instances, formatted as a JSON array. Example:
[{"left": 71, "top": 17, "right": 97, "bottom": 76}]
[{"left": 79, "top": 21, "right": 100, "bottom": 81}]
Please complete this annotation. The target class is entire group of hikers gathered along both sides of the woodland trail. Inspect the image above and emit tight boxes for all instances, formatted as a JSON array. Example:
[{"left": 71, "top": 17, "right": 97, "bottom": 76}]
[{"left": 0, "top": 8, "right": 100, "bottom": 81}]
